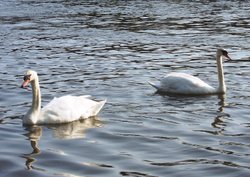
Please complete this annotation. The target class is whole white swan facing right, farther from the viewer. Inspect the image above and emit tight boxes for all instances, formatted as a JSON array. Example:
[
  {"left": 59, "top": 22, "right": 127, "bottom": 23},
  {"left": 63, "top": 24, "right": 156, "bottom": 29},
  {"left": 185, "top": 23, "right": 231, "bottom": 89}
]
[{"left": 149, "top": 49, "right": 231, "bottom": 95}]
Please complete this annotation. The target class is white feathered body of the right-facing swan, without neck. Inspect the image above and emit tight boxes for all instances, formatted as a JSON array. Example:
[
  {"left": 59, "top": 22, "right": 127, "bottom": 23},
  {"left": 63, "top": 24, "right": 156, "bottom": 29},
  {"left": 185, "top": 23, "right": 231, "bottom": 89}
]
[{"left": 150, "top": 73, "right": 216, "bottom": 95}]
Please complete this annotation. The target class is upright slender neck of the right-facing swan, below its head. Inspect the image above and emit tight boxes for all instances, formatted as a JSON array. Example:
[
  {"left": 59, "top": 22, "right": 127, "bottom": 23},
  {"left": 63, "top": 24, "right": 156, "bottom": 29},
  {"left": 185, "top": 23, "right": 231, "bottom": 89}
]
[{"left": 216, "top": 54, "right": 226, "bottom": 93}]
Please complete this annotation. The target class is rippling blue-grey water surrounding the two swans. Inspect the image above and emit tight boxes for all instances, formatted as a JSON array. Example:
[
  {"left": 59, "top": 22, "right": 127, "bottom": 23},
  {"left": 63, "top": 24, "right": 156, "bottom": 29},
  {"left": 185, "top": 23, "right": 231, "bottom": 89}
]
[{"left": 0, "top": 0, "right": 250, "bottom": 177}]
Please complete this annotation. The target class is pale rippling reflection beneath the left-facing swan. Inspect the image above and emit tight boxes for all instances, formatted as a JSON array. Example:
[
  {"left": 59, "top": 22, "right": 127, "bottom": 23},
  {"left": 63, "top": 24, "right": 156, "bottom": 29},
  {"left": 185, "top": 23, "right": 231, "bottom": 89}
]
[{"left": 22, "top": 117, "right": 102, "bottom": 170}]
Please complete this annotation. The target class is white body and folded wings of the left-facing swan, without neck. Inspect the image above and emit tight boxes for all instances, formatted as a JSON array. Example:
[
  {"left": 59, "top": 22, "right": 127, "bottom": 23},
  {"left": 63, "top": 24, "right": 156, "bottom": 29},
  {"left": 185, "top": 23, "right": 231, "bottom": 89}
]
[{"left": 39, "top": 95, "right": 106, "bottom": 124}]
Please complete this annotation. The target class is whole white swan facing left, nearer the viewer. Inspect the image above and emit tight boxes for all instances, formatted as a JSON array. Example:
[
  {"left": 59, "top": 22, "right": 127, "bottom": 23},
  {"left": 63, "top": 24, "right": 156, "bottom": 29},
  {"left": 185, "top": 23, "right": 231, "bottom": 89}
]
[{"left": 21, "top": 70, "right": 106, "bottom": 124}]
